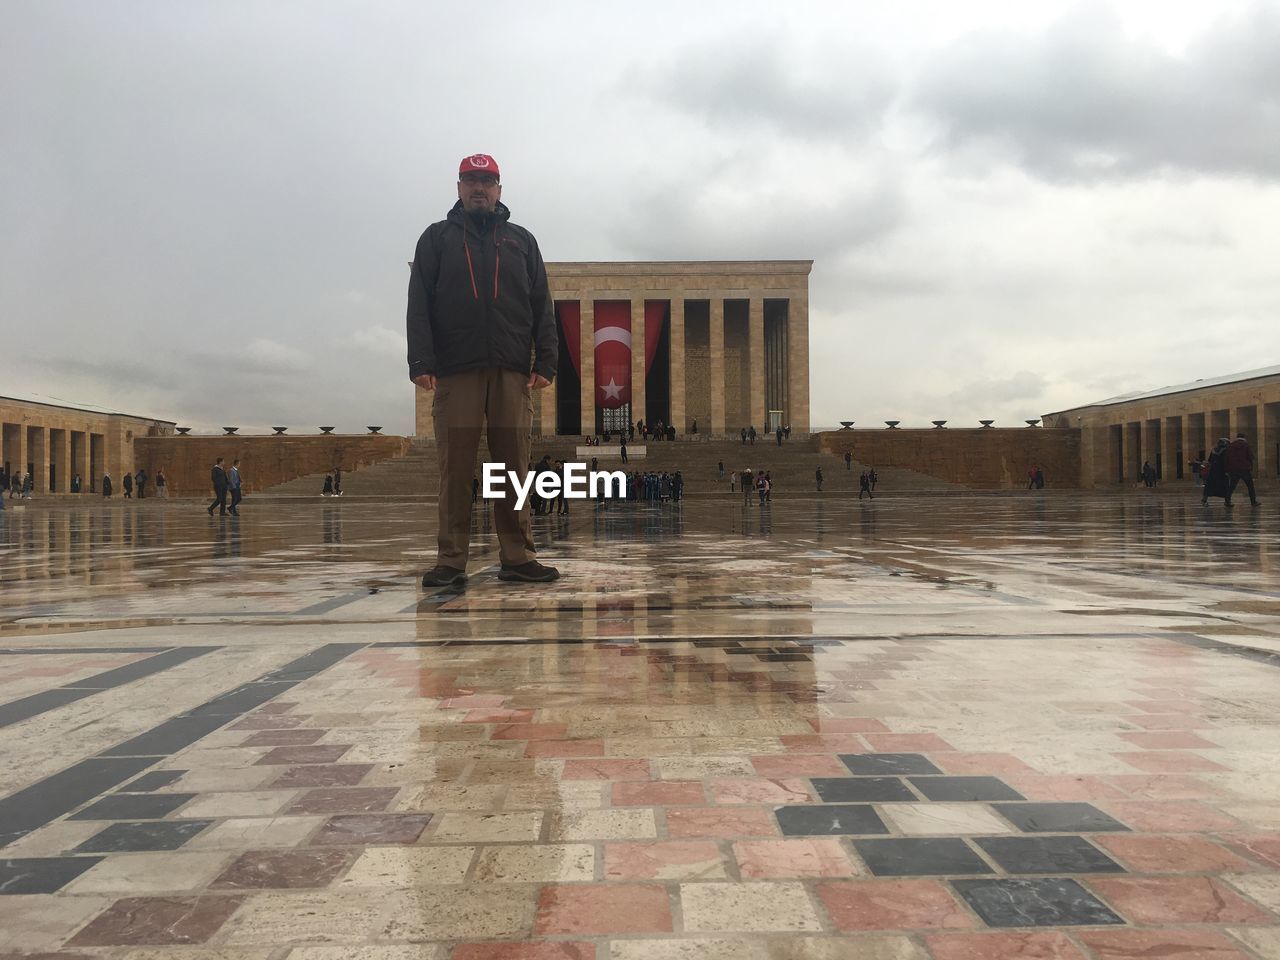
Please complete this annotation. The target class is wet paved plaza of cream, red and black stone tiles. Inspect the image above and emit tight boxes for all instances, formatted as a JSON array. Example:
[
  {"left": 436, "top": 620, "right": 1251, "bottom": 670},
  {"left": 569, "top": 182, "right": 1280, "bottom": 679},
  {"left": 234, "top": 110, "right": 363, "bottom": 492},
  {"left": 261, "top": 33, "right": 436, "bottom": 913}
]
[{"left": 0, "top": 492, "right": 1280, "bottom": 960}]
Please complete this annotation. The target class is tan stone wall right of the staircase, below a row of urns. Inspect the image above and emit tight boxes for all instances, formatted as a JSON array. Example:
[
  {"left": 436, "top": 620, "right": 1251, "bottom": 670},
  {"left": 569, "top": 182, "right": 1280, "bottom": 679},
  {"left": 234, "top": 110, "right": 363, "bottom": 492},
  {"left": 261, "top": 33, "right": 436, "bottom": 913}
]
[{"left": 819, "top": 426, "right": 1080, "bottom": 490}]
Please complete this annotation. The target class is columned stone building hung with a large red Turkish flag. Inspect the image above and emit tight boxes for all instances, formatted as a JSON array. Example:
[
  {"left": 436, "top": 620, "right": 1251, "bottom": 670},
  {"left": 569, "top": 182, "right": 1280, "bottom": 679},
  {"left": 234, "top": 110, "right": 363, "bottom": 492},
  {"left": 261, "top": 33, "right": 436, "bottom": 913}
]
[{"left": 415, "top": 260, "right": 813, "bottom": 438}]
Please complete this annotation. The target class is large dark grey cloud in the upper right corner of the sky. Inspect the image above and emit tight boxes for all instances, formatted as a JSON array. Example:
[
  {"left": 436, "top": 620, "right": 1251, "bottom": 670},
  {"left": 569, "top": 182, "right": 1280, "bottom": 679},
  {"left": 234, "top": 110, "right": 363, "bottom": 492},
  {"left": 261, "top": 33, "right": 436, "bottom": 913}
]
[{"left": 910, "top": 4, "right": 1280, "bottom": 180}]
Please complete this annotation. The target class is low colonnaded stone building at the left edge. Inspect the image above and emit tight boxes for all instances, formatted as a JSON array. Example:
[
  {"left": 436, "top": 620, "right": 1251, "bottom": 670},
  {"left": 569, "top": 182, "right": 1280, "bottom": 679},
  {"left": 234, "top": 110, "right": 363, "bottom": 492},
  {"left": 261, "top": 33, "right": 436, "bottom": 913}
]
[{"left": 0, "top": 397, "right": 174, "bottom": 493}]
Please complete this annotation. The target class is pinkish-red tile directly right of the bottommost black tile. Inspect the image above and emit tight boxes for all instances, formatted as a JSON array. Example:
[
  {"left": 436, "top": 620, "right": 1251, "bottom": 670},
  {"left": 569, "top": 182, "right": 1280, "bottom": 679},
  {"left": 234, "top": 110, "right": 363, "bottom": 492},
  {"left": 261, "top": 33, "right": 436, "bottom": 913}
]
[{"left": 1089, "top": 877, "right": 1274, "bottom": 924}]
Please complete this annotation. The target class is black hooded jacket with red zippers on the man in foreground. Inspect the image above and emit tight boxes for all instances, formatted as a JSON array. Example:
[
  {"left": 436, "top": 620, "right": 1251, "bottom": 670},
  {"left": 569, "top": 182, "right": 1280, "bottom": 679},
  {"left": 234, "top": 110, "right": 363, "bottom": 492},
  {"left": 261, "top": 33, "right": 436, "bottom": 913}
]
[{"left": 406, "top": 200, "right": 557, "bottom": 380}]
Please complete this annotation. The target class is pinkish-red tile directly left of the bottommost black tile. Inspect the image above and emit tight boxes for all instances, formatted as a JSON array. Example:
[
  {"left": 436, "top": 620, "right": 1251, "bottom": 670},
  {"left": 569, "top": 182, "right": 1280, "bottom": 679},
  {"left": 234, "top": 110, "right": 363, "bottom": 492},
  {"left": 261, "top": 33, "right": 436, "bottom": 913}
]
[{"left": 814, "top": 879, "right": 975, "bottom": 931}]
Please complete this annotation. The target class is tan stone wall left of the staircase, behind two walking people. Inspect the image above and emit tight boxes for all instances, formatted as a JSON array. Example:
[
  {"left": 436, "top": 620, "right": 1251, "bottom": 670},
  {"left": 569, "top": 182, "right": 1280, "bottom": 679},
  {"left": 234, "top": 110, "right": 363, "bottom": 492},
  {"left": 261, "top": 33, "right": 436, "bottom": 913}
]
[{"left": 133, "top": 434, "right": 412, "bottom": 497}]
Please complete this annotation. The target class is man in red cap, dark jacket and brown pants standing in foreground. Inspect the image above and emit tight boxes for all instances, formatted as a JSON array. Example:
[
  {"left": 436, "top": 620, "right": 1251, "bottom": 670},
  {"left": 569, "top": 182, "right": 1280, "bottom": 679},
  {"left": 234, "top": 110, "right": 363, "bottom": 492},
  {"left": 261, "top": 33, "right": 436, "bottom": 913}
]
[{"left": 407, "top": 154, "right": 559, "bottom": 586}]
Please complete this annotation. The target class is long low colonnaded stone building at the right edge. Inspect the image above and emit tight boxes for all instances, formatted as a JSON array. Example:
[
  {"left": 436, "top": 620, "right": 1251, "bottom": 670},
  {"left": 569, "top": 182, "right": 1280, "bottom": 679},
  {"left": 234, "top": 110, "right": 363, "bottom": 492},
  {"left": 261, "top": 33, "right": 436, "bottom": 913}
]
[{"left": 1044, "top": 366, "right": 1280, "bottom": 488}]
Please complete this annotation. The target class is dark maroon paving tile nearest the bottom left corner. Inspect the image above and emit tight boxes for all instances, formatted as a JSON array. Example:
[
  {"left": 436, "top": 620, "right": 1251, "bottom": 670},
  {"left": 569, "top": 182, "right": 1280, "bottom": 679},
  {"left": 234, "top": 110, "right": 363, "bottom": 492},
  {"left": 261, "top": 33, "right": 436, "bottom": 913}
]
[{"left": 67, "top": 896, "right": 244, "bottom": 947}]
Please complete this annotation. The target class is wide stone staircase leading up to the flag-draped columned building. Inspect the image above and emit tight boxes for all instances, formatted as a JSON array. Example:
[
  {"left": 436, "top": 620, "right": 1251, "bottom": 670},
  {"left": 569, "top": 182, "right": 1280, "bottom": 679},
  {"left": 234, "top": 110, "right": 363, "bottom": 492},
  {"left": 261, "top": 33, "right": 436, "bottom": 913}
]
[{"left": 262, "top": 436, "right": 968, "bottom": 499}]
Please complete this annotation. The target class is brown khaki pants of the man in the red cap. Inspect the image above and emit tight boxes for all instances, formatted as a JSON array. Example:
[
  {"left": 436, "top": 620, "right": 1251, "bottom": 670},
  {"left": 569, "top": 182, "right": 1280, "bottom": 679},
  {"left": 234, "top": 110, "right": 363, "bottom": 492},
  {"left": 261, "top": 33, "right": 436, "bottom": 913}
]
[{"left": 431, "top": 369, "right": 536, "bottom": 570}]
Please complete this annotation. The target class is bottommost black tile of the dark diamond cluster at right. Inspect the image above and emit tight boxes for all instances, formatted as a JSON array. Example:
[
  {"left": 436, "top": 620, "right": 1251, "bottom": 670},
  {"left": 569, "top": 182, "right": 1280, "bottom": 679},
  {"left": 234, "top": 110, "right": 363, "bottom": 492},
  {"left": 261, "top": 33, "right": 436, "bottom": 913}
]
[{"left": 951, "top": 877, "right": 1124, "bottom": 927}]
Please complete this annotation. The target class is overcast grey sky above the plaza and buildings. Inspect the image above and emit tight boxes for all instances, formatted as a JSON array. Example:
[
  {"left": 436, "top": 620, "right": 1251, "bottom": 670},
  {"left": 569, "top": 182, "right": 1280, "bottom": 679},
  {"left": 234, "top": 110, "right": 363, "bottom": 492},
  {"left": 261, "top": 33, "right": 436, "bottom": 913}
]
[{"left": 0, "top": 0, "right": 1280, "bottom": 433}]
